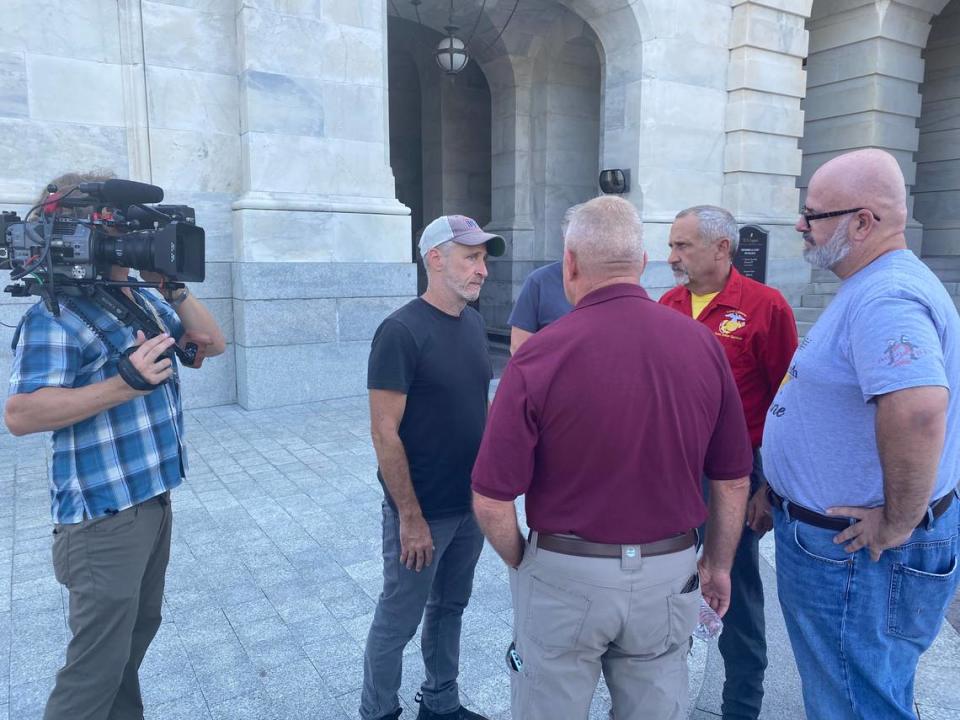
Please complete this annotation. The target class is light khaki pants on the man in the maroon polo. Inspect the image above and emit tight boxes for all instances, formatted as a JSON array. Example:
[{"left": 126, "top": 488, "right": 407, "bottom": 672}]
[{"left": 508, "top": 533, "right": 700, "bottom": 720}]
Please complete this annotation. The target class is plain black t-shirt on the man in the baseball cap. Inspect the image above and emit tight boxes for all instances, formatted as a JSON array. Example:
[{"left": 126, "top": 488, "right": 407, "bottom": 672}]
[{"left": 367, "top": 298, "right": 493, "bottom": 518}]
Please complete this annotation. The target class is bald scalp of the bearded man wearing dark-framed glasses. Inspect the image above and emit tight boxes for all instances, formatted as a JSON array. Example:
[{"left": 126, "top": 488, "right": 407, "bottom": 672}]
[{"left": 807, "top": 148, "right": 907, "bottom": 232}]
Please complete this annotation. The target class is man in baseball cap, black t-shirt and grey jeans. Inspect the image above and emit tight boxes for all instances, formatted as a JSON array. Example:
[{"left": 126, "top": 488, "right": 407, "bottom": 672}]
[{"left": 360, "top": 215, "right": 505, "bottom": 720}]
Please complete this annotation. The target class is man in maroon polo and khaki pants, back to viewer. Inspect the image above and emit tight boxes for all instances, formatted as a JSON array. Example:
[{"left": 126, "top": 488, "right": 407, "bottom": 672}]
[{"left": 473, "top": 196, "right": 752, "bottom": 720}]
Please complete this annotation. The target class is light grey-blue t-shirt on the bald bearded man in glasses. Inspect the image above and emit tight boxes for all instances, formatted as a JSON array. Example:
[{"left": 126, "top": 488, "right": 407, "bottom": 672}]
[{"left": 763, "top": 250, "right": 960, "bottom": 513}]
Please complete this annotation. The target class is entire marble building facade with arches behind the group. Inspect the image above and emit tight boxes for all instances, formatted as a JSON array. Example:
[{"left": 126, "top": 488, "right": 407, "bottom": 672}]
[{"left": 0, "top": 0, "right": 960, "bottom": 408}]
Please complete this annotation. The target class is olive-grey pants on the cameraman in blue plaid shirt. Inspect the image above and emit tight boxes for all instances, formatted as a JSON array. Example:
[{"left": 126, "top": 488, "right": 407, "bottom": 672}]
[{"left": 43, "top": 493, "right": 172, "bottom": 720}]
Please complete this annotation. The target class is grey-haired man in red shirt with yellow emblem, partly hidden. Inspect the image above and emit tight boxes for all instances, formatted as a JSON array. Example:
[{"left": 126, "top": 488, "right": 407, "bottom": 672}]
[{"left": 660, "top": 205, "right": 797, "bottom": 720}]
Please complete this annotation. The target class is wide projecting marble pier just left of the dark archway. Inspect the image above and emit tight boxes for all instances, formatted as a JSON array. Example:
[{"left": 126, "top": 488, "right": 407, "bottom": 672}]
[{"left": 233, "top": 0, "right": 416, "bottom": 408}]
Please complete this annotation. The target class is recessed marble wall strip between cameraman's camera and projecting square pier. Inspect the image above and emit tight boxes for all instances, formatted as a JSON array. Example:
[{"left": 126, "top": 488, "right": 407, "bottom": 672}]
[{"left": 141, "top": 0, "right": 240, "bottom": 407}]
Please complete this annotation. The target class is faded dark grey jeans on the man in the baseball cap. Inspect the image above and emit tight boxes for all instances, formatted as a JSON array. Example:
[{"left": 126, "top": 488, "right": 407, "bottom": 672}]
[{"left": 360, "top": 503, "right": 483, "bottom": 720}]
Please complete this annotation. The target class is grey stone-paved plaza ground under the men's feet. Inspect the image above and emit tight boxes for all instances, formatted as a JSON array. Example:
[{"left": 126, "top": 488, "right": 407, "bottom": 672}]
[{"left": 0, "top": 397, "right": 960, "bottom": 720}]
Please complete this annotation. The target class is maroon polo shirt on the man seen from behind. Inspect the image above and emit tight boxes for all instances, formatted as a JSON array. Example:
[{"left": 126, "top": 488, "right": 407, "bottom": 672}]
[{"left": 473, "top": 284, "right": 753, "bottom": 543}]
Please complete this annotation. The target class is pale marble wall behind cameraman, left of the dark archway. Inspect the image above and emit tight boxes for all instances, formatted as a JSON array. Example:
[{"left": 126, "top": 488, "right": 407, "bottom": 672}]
[{"left": 0, "top": 0, "right": 415, "bottom": 407}]
